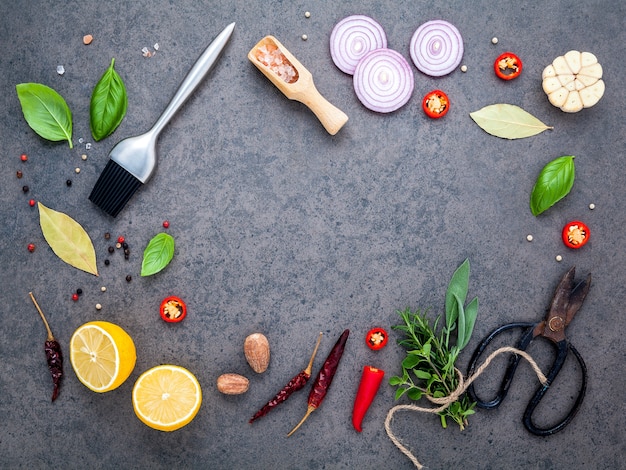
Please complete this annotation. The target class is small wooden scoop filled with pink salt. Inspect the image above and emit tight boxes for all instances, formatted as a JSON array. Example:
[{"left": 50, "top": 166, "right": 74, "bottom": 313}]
[{"left": 248, "top": 36, "right": 348, "bottom": 135}]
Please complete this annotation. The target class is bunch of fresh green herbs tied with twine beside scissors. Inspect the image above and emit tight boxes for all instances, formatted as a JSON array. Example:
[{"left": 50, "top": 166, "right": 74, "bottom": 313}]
[{"left": 389, "top": 259, "right": 478, "bottom": 430}]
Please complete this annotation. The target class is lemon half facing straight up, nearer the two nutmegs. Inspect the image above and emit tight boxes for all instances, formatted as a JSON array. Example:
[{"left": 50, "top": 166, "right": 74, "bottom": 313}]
[{"left": 133, "top": 365, "right": 202, "bottom": 431}]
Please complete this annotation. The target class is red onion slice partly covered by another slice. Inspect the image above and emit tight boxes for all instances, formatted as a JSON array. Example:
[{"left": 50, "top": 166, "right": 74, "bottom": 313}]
[{"left": 330, "top": 15, "right": 387, "bottom": 75}]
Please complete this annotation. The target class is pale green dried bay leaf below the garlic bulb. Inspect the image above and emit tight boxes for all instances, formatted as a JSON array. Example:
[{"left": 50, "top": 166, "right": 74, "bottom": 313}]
[{"left": 470, "top": 103, "right": 554, "bottom": 139}]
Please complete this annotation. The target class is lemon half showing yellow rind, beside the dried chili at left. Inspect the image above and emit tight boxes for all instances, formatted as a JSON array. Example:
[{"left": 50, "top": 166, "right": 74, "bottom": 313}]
[{"left": 70, "top": 321, "right": 137, "bottom": 393}]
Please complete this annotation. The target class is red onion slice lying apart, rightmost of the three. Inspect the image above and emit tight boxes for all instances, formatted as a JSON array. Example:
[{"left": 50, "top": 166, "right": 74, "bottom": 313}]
[{"left": 410, "top": 20, "right": 463, "bottom": 77}]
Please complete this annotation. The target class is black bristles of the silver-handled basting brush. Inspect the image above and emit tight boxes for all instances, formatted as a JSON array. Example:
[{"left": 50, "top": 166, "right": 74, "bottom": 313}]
[{"left": 89, "top": 160, "right": 142, "bottom": 217}]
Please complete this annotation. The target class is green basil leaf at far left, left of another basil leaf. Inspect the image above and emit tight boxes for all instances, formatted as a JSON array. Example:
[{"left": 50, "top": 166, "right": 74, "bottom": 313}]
[{"left": 15, "top": 83, "right": 73, "bottom": 148}]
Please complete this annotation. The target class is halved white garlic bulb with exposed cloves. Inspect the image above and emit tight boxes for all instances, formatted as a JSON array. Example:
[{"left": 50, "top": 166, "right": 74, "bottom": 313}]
[{"left": 541, "top": 51, "right": 604, "bottom": 113}]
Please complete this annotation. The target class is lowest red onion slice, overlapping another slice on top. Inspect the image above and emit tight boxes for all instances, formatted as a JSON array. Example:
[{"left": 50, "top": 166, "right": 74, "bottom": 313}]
[{"left": 353, "top": 49, "right": 415, "bottom": 113}]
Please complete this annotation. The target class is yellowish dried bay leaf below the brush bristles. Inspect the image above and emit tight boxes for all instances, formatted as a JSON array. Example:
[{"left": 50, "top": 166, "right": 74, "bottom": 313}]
[{"left": 38, "top": 202, "right": 98, "bottom": 276}]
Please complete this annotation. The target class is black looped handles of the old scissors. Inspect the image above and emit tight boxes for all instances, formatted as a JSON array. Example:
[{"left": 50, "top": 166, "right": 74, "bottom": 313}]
[{"left": 468, "top": 323, "right": 587, "bottom": 436}]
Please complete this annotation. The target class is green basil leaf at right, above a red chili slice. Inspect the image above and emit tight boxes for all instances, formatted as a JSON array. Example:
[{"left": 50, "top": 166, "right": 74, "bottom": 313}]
[{"left": 530, "top": 155, "right": 576, "bottom": 216}]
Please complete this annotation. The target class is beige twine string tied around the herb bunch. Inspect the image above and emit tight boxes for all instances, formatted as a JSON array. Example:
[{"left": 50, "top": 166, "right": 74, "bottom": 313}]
[{"left": 385, "top": 346, "right": 548, "bottom": 470}]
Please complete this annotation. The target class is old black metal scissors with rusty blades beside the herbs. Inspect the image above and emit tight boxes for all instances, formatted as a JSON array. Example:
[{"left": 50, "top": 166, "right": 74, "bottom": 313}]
[{"left": 468, "top": 267, "right": 591, "bottom": 436}]
